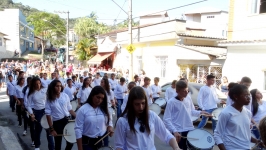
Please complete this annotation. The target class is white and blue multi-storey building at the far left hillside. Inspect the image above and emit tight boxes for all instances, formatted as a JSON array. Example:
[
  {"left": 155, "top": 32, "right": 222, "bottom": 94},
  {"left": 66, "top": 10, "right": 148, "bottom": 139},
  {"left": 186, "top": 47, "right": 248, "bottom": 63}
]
[{"left": 0, "top": 9, "right": 34, "bottom": 54}]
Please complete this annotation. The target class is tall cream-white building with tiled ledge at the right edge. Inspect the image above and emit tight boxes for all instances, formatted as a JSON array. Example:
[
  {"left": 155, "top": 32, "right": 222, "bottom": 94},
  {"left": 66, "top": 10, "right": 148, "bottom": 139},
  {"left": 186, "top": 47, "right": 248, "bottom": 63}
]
[{"left": 218, "top": 0, "right": 266, "bottom": 90}]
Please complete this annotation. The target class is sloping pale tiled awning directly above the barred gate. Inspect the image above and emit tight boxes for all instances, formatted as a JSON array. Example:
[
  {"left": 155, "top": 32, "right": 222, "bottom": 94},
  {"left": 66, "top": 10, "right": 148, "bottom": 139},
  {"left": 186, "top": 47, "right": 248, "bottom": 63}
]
[{"left": 176, "top": 44, "right": 227, "bottom": 59}]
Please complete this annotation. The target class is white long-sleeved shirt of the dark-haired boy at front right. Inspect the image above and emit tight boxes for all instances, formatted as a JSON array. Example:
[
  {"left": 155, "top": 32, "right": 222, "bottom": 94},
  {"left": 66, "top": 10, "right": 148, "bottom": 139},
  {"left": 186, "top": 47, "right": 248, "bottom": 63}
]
[{"left": 214, "top": 106, "right": 251, "bottom": 150}]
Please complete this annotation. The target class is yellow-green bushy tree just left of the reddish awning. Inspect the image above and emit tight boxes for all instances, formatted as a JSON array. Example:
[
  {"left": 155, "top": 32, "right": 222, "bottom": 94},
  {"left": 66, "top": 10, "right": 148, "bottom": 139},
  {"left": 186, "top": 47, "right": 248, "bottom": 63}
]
[{"left": 75, "top": 38, "right": 97, "bottom": 60}]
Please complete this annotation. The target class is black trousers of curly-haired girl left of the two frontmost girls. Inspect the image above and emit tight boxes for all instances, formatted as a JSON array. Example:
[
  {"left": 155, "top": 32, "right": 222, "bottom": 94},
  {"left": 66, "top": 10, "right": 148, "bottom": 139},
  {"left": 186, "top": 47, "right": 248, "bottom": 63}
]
[{"left": 53, "top": 118, "right": 73, "bottom": 150}]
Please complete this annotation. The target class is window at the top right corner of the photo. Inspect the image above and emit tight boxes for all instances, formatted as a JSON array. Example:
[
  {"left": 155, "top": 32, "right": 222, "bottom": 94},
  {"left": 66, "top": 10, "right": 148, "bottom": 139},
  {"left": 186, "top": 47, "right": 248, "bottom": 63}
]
[{"left": 251, "top": 0, "right": 266, "bottom": 14}]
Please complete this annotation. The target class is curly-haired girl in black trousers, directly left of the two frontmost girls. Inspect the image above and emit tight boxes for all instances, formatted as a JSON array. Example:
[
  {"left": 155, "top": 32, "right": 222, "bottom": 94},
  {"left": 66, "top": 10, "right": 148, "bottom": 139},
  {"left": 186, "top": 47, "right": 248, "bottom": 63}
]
[{"left": 45, "top": 79, "right": 76, "bottom": 150}]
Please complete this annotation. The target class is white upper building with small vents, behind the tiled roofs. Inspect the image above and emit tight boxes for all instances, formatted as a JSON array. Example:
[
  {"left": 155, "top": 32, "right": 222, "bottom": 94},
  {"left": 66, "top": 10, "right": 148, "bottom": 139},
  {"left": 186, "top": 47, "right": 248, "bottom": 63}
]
[{"left": 185, "top": 8, "right": 228, "bottom": 37}]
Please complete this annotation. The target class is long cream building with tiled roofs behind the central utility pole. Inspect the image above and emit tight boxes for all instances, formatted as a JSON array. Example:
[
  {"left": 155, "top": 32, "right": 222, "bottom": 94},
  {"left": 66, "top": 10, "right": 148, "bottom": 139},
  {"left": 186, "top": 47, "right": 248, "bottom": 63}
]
[{"left": 94, "top": 12, "right": 226, "bottom": 84}]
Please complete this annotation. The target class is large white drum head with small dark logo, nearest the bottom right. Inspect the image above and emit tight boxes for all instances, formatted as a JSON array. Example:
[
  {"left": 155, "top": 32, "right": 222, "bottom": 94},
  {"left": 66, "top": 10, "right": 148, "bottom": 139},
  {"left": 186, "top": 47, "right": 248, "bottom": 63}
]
[{"left": 187, "top": 129, "right": 215, "bottom": 149}]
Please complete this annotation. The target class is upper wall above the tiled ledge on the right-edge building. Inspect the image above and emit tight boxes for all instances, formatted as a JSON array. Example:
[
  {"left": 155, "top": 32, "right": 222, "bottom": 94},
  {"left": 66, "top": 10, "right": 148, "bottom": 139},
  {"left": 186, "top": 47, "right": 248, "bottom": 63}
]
[{"left": 228, "top": 0, "right": 266, "bottom": 40}]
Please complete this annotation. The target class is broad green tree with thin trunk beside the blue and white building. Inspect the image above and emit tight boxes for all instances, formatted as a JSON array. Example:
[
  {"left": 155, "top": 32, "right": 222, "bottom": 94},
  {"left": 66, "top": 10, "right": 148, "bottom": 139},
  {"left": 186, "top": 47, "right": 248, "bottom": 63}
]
[{"left": 27, "top": 12, "right": 66, "bottom": 55}]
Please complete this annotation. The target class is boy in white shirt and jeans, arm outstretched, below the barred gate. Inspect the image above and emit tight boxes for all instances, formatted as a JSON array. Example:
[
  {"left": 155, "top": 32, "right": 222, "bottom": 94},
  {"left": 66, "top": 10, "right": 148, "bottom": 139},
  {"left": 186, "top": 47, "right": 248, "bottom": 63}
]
[{"left": 197, "top": 74, "right": 225, "bottom": 131}]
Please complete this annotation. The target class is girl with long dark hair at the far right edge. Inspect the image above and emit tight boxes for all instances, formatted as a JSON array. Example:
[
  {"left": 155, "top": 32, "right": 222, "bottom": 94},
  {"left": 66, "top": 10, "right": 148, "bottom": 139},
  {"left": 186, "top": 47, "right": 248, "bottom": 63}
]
[{"left": 250, "top": 89, "right": 266, "bottom": 139}]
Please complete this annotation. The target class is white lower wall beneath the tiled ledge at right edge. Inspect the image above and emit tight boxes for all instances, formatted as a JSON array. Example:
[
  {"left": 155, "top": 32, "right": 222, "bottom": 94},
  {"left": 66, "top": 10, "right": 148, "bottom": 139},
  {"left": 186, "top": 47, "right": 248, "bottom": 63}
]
[{"left": 223, "top": 46, "right": 266, "bottom": 89}]
